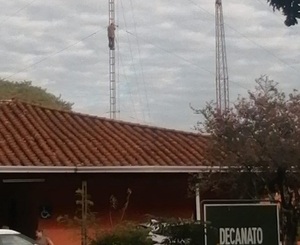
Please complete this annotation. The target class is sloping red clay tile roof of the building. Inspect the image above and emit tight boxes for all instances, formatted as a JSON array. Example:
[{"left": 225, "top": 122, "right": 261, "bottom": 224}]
[{"left": 0, "top": 101, "right": 206, "bottom": 170}]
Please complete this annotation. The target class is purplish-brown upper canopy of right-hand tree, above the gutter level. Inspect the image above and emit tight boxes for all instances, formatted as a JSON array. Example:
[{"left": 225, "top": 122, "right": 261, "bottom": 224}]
[{"left": 201, "top": 77, "right": 300, "bottom": 174}]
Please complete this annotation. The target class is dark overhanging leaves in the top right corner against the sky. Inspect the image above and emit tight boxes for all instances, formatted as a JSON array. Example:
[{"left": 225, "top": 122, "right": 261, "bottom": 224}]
[{"left": 267, "top": 0, "right": 300, "bottom": 26}]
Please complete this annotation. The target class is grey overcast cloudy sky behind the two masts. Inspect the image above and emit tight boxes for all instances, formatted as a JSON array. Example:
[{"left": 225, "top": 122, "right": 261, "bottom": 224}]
[{"left": 0, "top": 0, "right": 300, "bottom": 131}]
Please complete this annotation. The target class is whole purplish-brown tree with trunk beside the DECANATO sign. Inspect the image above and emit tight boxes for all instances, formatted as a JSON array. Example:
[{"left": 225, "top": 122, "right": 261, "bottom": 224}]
[{"left": 197, "top": 76, "right": 300, "bottom": 245}]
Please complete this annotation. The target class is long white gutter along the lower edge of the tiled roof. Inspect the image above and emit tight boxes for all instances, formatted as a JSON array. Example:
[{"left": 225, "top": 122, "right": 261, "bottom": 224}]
[{"left": 0, "top": 166, "right": 228, "bottom": 174}]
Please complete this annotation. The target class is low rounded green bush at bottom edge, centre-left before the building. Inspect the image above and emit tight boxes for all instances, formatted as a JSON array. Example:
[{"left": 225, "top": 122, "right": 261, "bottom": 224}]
[{"left": 90, "top": 223, "right": 152, "bottom": 245}]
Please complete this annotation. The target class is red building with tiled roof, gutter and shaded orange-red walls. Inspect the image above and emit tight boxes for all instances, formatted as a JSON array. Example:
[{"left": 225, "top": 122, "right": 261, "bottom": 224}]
[{"left": 0, "top": 101, "right": 207, "bottom": 244}]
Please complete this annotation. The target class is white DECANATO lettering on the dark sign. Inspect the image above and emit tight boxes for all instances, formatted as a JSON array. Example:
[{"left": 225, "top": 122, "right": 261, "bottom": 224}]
[{"left": 219, "top": 227, "right": 264, "bottom": 245}]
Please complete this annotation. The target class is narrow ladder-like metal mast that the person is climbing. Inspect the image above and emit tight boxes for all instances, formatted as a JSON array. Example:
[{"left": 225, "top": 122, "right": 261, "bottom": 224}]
[{"left": 108, "top": 0, "right": 117, "bottom": 119}]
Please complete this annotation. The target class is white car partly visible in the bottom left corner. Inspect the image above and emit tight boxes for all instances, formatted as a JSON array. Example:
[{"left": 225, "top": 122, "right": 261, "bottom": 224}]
[{"left": 0, "top": 229, "right": 36, "bottom": 245}]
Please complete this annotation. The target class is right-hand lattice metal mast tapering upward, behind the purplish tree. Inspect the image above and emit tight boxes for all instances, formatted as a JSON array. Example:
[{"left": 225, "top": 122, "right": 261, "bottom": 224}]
[{"left": 216, "top": 0, "right": 229, "bottom": 112}]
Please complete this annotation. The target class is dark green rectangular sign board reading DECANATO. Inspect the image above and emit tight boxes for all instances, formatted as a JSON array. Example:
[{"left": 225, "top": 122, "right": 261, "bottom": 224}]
[{"left": 204, "top": 204, "right": 279, "bottom": 245}]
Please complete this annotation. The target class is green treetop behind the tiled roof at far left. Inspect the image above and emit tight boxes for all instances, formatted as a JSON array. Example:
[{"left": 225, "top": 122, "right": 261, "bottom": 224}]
[{"left": 0, "top": 79, "right": 73, "bottom": 110}]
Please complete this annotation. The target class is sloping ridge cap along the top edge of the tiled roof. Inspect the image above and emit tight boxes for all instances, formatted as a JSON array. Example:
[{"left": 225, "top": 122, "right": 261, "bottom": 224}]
[{"left": 0, "top": 98, "right": 204, "bottom": 136}]
